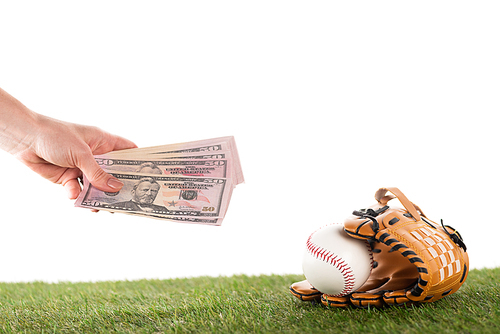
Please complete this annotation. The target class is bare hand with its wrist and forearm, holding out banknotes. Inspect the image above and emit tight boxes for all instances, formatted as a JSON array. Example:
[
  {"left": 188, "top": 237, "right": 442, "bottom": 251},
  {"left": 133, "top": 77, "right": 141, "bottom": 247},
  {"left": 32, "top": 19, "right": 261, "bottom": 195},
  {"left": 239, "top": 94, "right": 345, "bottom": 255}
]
[{"left": 0, "top": 89, "right": 137, "bottom": 199}]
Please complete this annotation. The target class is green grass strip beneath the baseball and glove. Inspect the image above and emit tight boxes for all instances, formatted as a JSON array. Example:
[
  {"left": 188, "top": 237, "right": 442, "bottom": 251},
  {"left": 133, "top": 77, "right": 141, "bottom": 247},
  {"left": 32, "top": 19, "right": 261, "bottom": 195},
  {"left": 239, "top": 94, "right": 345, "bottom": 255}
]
[{"left": 0, "top": 268, "right": 500, "bottom": 333}]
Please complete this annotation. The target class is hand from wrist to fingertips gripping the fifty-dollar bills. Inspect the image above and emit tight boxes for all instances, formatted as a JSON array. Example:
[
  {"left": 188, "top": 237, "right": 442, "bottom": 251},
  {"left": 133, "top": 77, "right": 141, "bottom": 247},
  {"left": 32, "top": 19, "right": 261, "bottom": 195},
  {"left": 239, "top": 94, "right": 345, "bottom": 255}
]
[{"left": 14, "top": 115, "right": 137, "bottom": 199}]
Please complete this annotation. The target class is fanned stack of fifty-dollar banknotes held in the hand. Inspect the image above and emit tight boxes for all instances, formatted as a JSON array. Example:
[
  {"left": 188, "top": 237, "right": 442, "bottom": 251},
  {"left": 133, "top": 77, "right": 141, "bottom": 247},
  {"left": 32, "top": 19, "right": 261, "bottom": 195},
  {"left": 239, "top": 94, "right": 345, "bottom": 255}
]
[{"left": 75, "top": 136, "right": 244, "bottom": 225}]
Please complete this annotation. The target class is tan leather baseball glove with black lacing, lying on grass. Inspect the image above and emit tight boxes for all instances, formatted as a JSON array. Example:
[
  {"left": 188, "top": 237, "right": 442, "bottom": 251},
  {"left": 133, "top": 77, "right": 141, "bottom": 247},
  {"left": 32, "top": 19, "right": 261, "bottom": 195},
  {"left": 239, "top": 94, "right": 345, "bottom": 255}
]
[{"left": 290, "top": 188, "right": 469, "bottom": 307}]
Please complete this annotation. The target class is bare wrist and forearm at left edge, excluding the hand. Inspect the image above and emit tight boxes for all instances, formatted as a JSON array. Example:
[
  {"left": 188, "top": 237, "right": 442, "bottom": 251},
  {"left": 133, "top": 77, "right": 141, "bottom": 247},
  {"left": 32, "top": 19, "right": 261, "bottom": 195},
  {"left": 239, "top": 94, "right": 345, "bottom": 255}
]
[{"left": 0, "top": 88, "right": 42, "bottom": 154}]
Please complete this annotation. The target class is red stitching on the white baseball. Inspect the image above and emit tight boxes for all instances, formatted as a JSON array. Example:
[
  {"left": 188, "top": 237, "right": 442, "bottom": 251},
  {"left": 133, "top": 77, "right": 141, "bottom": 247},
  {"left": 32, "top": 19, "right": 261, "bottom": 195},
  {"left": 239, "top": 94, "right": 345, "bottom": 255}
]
[{"left": 306, "top": 226, "right": 373, "bottom": 297}]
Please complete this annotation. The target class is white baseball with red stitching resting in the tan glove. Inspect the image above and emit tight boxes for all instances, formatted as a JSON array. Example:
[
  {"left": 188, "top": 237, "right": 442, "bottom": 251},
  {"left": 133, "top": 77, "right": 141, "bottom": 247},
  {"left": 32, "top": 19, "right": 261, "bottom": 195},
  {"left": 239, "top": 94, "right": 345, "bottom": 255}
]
[{"left": 302, "top": 224, "right": 373, "bottom": 297}]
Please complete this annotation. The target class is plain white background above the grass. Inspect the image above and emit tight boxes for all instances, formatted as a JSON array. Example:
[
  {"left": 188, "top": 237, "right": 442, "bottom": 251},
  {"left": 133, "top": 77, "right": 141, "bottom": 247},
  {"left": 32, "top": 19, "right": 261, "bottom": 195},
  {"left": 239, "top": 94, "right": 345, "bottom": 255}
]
[{"left": 0, "top": 1, "right": 500, "bottom": 282}]
